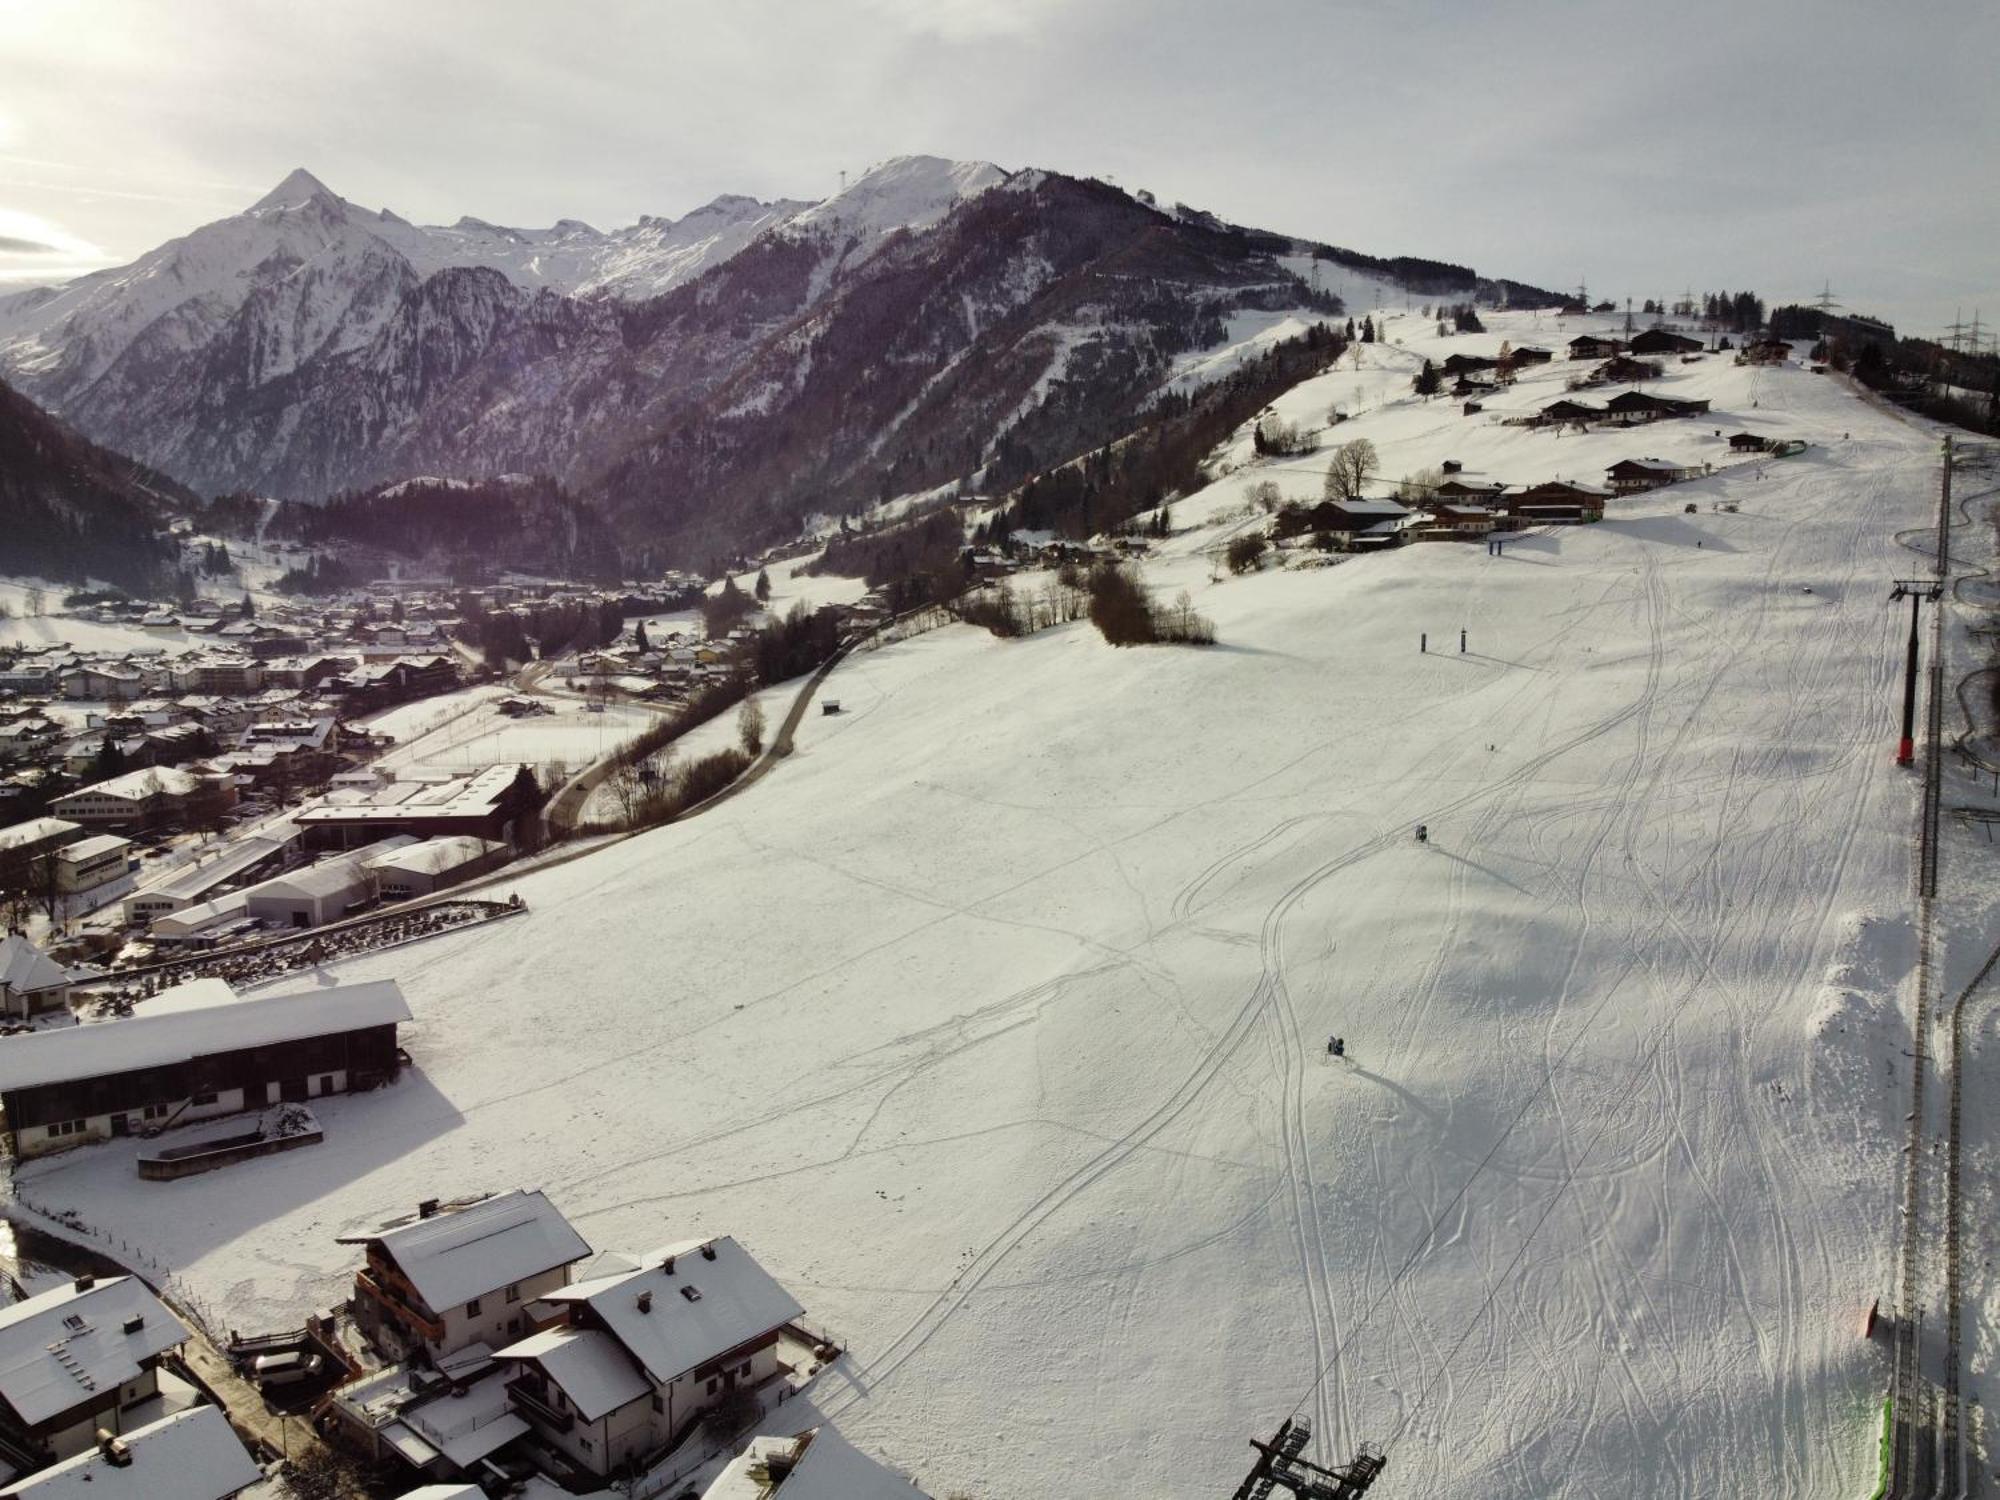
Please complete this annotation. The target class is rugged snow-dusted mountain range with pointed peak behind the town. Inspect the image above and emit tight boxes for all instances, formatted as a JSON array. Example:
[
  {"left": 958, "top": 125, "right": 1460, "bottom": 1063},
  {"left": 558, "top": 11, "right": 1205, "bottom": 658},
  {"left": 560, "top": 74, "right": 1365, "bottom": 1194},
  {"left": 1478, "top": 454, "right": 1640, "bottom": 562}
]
[{"left": 0, "top": 156, "right": 1544, "bottom": 560}]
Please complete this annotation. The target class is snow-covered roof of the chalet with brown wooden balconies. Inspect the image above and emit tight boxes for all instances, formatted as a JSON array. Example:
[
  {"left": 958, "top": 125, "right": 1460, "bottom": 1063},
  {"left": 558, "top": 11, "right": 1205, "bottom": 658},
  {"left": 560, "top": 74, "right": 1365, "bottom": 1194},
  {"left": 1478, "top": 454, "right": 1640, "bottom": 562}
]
[{"left": 368, "top": 1188, "right": 590, "bottom": 1312}]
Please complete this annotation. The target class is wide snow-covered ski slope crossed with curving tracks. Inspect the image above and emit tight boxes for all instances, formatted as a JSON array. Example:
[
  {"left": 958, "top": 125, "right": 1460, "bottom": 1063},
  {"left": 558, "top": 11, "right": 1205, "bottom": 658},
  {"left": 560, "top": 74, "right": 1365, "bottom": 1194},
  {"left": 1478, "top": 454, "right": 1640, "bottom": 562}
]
[{"left": 20, "top": 318, "right": 1952, "bottom": 1500}]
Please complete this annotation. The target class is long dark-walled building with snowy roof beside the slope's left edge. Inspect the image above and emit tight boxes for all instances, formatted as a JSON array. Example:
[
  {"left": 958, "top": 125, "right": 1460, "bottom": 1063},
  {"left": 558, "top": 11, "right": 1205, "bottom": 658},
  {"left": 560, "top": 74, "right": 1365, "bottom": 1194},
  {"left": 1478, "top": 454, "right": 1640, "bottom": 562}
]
[{"left": 0, "top": 980, "right": 410, "bottom": 1160}]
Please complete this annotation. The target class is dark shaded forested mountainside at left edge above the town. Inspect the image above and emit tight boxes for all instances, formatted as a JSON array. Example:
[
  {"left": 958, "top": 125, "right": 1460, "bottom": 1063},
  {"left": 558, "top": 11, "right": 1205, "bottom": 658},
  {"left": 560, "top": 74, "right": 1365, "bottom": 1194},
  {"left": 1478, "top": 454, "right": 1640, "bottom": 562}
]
[{"left": 0, "top": 384, "right": 194, "bottom": 590}]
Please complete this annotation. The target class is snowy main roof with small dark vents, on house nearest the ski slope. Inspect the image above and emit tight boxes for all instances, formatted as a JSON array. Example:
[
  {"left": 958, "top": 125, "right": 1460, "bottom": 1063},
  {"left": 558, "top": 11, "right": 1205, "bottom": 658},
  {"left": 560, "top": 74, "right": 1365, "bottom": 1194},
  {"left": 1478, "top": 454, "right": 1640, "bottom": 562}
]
[{"left": 546, "top": 1234, "right": 804, "bottom": 1386}]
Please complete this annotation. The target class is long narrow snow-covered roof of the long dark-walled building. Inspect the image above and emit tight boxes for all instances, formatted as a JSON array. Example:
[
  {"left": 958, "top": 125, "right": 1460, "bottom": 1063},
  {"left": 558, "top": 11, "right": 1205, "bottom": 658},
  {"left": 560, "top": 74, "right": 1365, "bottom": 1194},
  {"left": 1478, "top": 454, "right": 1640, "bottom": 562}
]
[{"left": 0, "top": 980, "right": 410, "bottom": 1094}]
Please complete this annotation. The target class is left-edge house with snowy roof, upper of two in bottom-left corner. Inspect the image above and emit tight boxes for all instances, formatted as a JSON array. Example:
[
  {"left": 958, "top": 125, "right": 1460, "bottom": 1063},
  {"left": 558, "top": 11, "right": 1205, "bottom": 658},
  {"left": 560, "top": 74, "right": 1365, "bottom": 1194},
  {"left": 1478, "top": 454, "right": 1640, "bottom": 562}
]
[{"left": 0, "top": 1276, "right": 188, "bottom": 1464}]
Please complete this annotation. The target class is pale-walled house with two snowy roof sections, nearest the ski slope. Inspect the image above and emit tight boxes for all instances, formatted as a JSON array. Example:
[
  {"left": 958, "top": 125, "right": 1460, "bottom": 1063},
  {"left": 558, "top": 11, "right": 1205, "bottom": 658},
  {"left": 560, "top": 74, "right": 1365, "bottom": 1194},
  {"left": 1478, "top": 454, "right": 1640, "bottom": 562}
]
[{"left": 494, "top": 1236, "right": 814, "bottom": 1474}]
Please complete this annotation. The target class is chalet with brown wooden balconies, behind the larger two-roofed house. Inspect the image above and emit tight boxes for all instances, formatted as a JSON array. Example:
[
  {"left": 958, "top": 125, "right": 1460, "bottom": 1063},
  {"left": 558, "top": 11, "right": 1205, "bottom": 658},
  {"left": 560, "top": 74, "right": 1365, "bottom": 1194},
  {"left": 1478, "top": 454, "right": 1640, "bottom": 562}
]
[{"left": 340, "top": 1188, "right": 590, "bottom": 1360}]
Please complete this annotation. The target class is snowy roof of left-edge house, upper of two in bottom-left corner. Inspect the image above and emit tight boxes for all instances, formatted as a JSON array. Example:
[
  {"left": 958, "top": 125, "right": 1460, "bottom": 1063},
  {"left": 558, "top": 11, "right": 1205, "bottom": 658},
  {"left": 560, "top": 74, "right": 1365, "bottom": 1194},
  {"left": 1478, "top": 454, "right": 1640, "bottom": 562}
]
[{"left": 0, "top": 1276, "right": 188, "bottom": 1426}]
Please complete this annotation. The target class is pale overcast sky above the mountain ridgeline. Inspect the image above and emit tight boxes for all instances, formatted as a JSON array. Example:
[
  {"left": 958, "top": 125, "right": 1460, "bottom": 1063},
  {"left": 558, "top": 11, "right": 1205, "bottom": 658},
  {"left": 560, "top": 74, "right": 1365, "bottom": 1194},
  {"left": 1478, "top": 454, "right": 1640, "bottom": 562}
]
[{"left": 0, "top": 0, "right": 2000, "bottom": 334}]
